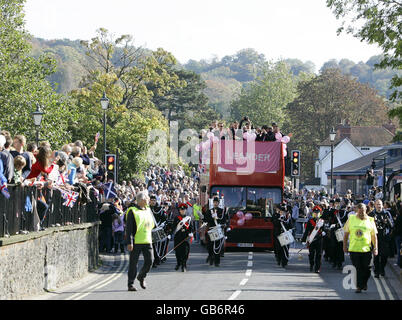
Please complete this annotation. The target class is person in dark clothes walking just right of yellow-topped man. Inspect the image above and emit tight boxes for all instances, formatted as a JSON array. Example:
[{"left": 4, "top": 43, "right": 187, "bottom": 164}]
[{"left": 369, "top": 199, "right": 394, "bottom": 278}]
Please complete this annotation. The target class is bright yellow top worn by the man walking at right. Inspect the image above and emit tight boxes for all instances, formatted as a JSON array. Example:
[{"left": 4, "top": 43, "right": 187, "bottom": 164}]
[{"left": 345, "top": 215, "right": 376, "bottom": 252}]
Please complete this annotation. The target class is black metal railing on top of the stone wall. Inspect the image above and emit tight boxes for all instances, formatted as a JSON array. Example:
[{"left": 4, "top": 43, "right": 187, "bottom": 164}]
[{"left": 0, "top": 185, "right": 99, "bottom": 238}]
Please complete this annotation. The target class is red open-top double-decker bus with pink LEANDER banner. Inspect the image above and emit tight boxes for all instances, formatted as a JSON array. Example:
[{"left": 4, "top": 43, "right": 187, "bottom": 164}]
[{"left": 200, "top": 140, "right": 285, "bottom": 249}]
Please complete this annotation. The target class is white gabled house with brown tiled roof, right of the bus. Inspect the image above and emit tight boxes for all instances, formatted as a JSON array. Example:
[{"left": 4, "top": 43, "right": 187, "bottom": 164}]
[{"left": 315, "top": 121, "right": 396, "bottom": 187}]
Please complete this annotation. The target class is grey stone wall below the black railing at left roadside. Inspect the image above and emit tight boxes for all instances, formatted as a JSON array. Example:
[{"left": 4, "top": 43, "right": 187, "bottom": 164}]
[{"left": 0, "top": 222, "right": 100, "bottom": 300}]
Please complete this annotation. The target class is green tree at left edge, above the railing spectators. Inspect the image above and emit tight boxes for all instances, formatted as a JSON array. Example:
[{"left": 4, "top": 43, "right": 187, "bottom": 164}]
[{"left": 0, "top": 0, "right": 73, "bottom": 147}]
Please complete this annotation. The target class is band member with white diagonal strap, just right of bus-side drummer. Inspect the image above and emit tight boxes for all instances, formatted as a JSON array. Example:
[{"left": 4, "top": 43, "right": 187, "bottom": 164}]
[{"left": 302, "top": 206, "right": 325, "bottom": 273}]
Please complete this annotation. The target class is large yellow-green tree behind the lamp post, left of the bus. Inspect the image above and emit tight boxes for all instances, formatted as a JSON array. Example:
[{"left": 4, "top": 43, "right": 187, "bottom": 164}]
[{"left": 71, "top": 28, "right": 196, "bottom": 179}]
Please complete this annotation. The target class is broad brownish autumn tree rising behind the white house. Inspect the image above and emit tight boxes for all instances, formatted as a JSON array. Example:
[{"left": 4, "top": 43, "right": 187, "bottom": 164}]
[{"left": 286, "top": 69, "right": 388, "bottom": 177}]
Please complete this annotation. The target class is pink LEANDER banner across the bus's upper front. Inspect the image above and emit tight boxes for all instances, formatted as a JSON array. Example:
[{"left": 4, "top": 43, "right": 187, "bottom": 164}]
[{"left": 213, "top": 140, "right": 282, "bottom": 174}]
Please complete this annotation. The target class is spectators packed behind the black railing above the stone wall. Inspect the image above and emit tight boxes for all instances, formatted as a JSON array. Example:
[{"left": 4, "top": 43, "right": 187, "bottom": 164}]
[{"left": 0, "top": 130, "right": 105, "bottom": 230}]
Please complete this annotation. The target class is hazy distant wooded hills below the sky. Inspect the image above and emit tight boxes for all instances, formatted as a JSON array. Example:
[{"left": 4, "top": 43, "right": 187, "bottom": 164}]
[{"left": 31, "top": 38, "right": 402, "bottom": 118}]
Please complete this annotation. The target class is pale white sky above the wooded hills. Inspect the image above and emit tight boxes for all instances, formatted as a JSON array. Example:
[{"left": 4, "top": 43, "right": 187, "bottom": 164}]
[{"left": 25, "top": 0, "right": 381, "bottom": 71}]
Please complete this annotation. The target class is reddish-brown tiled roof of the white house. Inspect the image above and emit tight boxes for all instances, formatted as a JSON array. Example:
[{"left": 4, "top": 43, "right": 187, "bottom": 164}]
[{"left": 318, "top": 126, "right": 394, "bottom": 147}]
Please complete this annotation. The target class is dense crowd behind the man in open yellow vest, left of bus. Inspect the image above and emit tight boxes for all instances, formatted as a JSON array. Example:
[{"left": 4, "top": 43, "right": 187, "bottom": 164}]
[{"left": 99, "top": 166, "right": 200, "bottom": 253}]
